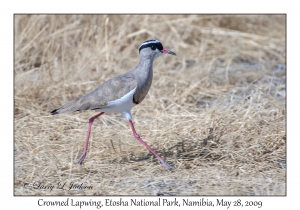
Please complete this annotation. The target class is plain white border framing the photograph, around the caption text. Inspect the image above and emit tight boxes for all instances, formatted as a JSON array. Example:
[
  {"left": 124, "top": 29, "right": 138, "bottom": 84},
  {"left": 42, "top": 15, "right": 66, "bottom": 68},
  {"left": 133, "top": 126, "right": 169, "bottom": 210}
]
[{"left": 4, "top": 0, "right": 300, "bottom": 209}]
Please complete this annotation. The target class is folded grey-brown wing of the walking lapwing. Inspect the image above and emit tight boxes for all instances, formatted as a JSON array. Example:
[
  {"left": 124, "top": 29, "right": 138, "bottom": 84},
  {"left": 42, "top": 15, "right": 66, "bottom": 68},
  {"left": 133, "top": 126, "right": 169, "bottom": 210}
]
[{"left": 51, "top": 73, "right": 137, "bottom": 114}]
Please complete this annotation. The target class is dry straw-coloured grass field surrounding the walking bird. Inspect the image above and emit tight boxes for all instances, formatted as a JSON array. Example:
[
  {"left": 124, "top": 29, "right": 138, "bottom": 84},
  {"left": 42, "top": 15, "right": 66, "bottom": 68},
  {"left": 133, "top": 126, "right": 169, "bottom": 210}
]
[{"left": 14, "top": 15, "right": 286, "bottom": 195}]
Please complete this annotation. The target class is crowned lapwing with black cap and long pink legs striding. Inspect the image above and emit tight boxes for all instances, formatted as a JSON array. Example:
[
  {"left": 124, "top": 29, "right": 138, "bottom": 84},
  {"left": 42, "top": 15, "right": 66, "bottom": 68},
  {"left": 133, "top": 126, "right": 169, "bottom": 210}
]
[{"left": 51, "top": 39, "right": 176, "bottom": 169}]
